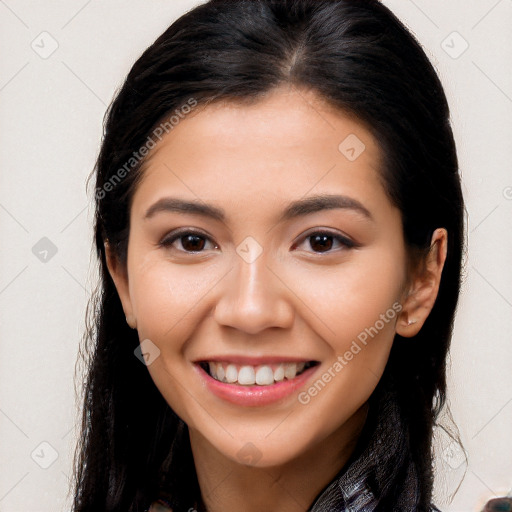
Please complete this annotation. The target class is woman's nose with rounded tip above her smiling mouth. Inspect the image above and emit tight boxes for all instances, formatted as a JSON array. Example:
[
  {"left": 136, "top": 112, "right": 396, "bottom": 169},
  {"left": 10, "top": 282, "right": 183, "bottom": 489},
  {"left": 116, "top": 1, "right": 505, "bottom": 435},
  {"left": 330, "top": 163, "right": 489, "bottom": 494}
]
[{"left": 214, "top": 249, "right": 294, "bottom": 334}]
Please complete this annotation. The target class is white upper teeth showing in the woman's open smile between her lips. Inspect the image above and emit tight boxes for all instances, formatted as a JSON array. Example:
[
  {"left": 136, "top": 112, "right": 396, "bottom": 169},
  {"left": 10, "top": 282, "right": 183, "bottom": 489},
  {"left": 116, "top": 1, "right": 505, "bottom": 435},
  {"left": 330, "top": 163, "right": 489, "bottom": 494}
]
[{"left": 199, "top": 361, "right": 319, "bottom": 386}]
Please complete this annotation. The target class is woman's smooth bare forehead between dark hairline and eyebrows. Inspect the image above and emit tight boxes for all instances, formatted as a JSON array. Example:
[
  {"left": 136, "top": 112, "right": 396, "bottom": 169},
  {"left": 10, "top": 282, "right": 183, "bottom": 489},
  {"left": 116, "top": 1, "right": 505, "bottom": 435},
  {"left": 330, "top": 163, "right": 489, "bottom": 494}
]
[{"left": 134, "top": 88, "right": 383, "bottom": 222}]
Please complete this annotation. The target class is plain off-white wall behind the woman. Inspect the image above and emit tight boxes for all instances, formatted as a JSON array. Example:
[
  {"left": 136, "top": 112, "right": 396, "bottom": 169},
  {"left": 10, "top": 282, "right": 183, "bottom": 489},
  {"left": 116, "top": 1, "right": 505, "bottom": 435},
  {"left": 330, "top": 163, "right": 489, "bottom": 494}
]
[{"left": 0, "top": 0, "right": 512, "bottom": 512}]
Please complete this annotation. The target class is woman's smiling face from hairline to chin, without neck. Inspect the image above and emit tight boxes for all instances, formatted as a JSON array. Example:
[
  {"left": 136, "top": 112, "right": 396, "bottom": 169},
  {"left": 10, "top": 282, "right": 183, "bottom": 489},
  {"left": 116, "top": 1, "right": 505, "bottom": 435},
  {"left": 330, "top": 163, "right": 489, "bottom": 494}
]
[{"left": 110, "top": 88, "right": 414, "bottom": 466}]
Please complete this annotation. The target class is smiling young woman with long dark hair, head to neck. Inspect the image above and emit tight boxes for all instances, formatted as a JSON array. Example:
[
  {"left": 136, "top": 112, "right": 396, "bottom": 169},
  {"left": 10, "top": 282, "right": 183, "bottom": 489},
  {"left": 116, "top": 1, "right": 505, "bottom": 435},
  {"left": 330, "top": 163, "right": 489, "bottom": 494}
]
[{"left": 74, "top": 0, "right": 464, "bottom": 512}]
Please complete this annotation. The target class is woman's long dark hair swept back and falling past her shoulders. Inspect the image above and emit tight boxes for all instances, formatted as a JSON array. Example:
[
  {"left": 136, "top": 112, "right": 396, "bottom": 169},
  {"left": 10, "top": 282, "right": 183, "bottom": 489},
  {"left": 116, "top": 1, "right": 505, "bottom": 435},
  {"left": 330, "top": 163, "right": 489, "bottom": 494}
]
[{"left": 73, "top": 0, "right": 464, "bottom": 512}]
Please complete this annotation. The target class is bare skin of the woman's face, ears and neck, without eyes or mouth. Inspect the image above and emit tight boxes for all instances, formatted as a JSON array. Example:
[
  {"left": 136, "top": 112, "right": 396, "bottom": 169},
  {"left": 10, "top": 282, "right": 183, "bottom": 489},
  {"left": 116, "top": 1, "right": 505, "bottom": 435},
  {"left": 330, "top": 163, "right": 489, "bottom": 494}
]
[{"left": 107, "top": 87, "right": 447, "bottom": 512}]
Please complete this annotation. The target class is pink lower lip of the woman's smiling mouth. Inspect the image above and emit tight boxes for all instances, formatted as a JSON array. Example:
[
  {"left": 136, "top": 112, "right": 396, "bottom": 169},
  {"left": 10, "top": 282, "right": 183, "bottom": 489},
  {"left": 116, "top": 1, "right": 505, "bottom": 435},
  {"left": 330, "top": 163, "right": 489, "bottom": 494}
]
[{"left": 194, "top": 364, "right": 319, "bottom": 407}]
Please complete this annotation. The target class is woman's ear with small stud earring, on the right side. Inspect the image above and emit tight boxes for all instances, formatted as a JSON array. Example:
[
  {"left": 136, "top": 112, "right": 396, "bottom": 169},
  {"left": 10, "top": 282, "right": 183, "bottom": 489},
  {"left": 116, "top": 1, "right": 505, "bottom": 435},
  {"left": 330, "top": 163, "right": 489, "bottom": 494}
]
[{"left": 396, "top": 228, "right": 448, "bottom": 338}]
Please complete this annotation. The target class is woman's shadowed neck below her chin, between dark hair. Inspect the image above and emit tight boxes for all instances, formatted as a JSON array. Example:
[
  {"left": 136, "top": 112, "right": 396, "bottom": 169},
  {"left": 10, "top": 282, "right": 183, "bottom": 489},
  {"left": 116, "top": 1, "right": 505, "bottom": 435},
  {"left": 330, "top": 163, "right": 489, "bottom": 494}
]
[{"left": 189, "top": 404, "right": 368, "bottom": 512}]
